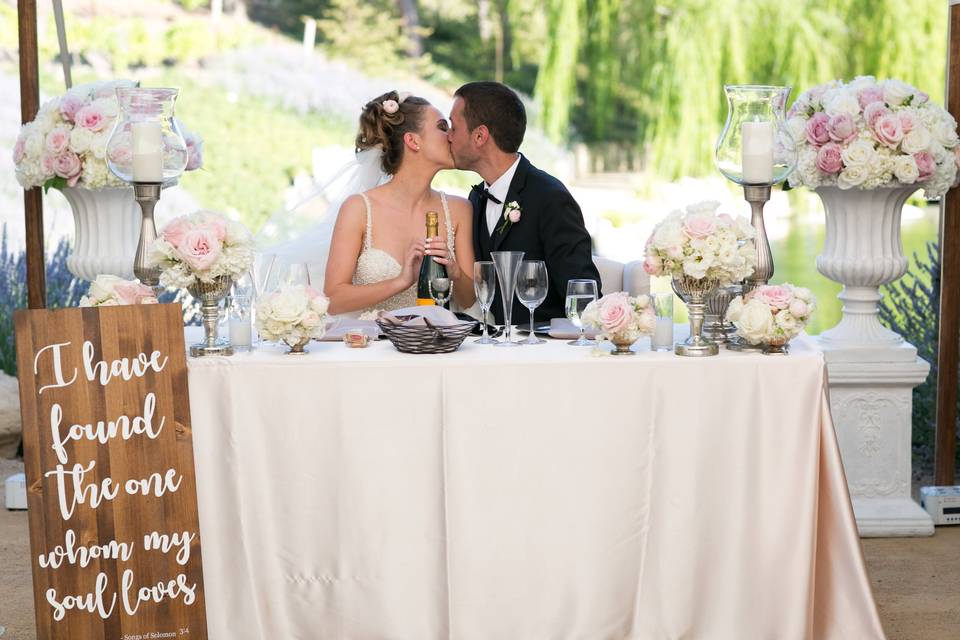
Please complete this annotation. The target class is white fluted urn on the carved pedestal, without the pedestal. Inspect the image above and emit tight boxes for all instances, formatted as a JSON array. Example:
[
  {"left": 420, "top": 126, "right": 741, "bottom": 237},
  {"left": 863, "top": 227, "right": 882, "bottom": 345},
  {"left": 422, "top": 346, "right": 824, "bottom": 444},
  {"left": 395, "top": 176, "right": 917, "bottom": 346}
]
[{"left": 816, "top": 185, "right": 919, "bottom": 348}]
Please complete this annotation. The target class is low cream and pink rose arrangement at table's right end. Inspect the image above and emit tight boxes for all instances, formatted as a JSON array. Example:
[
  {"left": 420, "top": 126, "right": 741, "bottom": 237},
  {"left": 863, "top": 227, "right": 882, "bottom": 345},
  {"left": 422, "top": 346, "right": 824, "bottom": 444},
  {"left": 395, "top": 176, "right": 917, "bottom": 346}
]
[{"left": 726, "top": 284, "right": 817, "bottom": 345}]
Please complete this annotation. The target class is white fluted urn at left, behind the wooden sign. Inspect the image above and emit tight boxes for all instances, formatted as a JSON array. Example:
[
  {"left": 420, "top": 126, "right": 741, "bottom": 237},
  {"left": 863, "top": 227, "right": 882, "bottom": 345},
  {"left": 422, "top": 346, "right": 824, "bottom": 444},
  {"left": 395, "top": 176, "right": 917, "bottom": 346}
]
[{"left": 61, "top": 187, "right": 141, "bottom": 281}]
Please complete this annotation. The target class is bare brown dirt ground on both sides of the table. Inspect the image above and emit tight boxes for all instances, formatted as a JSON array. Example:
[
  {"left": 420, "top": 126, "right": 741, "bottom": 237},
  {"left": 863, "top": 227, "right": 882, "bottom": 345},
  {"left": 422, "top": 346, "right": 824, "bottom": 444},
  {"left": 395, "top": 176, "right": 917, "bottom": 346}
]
[{"left": 0, "top": 460, "right": 960, "bottom": 640}]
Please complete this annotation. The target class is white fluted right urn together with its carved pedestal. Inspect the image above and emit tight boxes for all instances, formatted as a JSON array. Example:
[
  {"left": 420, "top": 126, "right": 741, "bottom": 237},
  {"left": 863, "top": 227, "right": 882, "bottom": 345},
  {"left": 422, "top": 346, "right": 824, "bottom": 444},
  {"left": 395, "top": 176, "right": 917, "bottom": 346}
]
[{"left": 816, "top": 185, "right": 933, "bottom": 536}]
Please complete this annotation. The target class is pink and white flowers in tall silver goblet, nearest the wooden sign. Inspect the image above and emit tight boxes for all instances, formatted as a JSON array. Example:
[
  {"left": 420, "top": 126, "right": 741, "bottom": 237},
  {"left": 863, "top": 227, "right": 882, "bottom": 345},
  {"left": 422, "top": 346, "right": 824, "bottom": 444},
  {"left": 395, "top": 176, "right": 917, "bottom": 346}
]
[{"left": 147, "top": 211, "right": 253, "bottom": 289}]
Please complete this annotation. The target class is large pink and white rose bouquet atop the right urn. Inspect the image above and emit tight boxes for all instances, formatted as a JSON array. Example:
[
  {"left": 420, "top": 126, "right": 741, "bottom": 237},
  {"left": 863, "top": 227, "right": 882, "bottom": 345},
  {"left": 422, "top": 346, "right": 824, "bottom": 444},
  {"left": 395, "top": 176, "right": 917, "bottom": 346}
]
[{"left": 787, "top": 76, "right": 960, "bottom": 199}]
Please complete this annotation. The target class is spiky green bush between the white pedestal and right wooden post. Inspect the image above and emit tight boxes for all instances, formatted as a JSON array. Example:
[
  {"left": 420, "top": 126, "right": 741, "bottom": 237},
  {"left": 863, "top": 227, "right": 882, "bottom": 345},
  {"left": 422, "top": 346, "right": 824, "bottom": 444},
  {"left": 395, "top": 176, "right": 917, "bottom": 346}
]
[{"left": 880, "top": 242, "right": 960, "bottom": 469}]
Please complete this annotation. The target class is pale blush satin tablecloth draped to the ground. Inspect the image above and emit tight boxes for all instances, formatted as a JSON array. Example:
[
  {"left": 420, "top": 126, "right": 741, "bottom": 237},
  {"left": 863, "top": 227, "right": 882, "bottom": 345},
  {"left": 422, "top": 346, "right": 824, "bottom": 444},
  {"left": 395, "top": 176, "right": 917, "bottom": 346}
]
[{"left": 189, "top": 338, "right": 883, "bottom": 640}]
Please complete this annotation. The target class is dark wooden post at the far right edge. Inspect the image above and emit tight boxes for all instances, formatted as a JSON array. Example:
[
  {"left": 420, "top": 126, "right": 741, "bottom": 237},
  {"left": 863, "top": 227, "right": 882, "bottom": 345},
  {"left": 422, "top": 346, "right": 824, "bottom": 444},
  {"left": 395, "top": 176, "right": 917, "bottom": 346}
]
[{"left": 934, "top": 0, "right": 960, "bottom": 485}]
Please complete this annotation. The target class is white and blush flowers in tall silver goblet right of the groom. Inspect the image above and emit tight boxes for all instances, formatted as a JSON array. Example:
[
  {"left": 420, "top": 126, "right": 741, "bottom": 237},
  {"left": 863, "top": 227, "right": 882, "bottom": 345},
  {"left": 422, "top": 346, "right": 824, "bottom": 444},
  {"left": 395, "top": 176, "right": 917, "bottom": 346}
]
[{"left": 643, "top": 202, "right": 757, "bottom": 286}]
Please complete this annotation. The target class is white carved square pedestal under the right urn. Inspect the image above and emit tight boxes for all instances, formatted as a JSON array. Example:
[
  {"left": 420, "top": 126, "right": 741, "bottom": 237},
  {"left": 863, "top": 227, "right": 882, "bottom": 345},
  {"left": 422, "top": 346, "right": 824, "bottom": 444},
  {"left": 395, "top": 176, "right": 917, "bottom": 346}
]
[{"left": 820, "top": 340, "right": 933, "bottom": 537}]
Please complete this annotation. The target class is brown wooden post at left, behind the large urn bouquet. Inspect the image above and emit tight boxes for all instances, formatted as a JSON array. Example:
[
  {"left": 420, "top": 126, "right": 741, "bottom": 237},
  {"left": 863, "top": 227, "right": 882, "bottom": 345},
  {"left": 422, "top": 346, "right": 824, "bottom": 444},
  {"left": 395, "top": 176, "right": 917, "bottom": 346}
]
[{"left": 17, "top": 0, "right": 47, "bottom": 309}]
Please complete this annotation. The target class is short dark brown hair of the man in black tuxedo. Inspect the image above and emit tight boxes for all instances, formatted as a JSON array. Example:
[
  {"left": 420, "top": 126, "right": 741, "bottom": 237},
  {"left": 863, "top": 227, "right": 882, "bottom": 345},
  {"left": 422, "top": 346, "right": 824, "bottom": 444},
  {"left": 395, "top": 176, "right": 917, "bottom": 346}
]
[{"left": 453, "top": 82, "right": 527, "bottom": 153}]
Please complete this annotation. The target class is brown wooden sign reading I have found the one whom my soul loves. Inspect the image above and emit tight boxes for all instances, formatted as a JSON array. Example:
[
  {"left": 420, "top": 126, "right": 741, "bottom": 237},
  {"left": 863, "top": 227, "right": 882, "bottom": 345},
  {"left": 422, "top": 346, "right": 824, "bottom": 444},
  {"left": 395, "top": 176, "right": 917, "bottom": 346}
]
[{"left": 15, "top": 304, "right": 207, "bottom": 640}]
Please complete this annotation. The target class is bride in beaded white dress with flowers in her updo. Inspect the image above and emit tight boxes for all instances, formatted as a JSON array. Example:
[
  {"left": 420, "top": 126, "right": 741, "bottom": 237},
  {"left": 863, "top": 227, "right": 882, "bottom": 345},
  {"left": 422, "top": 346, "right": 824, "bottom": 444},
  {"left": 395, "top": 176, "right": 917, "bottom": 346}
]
[{"left": 324, "top": 91, "right": 475, "bottom": 314}]
